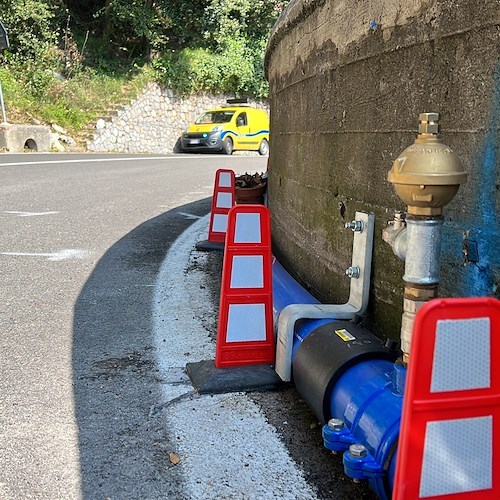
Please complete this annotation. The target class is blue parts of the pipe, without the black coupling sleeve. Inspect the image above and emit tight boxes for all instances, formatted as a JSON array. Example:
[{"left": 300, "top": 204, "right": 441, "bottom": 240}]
[{"left": 273, "top": 261, "right": 406, "bottom": 499}]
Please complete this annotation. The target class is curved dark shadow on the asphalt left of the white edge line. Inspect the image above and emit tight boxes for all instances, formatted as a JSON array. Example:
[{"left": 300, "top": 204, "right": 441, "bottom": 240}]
[{"left": 72, "top": 199, "right": 210, "bottom": 499}]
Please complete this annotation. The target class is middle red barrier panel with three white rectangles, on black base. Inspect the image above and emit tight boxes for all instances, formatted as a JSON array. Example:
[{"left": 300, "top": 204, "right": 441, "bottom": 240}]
[{"left": 215, "top": 205, "right": 275, "bottom": 368}]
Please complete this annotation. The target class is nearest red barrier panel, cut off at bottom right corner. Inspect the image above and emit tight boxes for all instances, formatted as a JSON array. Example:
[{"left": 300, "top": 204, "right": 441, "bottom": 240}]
[{"left": 393, "top": 298, "right": 500, "bottom": 500}]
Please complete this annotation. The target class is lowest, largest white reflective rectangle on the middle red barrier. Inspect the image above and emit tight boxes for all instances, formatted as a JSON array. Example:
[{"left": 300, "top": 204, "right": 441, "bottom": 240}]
[{"left": 226, "top": 304, "right": 266, "bottom": 342}]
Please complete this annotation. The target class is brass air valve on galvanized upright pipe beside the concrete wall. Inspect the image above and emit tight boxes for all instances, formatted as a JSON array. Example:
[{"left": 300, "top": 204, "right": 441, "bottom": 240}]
[{"left": 383, "top": 113, "right": 467, "bottom": 362}]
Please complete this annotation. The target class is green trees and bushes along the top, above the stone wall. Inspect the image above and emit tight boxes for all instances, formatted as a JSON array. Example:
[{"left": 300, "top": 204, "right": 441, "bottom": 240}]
[{"left": 0, "top": 0, "right": 283, "bottom": 100}]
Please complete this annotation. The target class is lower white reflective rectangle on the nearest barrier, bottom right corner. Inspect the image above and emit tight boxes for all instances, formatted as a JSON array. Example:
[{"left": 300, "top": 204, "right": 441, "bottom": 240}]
[{"left": 420, "top": 415, "right": 493, "bottom": 498}]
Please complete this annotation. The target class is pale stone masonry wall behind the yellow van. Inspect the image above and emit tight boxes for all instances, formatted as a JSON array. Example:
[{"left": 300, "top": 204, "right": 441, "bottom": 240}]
[{"left": 87, "top": 84, "right": 267, "bottom": 154}]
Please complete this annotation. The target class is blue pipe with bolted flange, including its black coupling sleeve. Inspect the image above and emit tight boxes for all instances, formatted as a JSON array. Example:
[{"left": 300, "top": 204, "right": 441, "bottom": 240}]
[{"left": 273, "top": 265, "right": 406, "bottom": 500}]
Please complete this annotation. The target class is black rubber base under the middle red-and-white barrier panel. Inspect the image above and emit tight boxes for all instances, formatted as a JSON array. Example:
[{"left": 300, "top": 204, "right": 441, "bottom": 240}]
[{"left": 186, "top": 360, "right": 292, "bottom": 394}]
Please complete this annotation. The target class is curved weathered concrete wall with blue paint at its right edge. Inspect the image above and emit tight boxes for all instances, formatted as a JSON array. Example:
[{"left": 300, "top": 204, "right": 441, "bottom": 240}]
[{"left": 266, "top": 0, "right": 500, "bottom": 338}]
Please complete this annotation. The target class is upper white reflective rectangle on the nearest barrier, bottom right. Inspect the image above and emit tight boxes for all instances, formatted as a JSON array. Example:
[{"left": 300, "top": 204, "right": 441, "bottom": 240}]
[{"left": 431, "top": 318, "right": 491, "bottom": 392}]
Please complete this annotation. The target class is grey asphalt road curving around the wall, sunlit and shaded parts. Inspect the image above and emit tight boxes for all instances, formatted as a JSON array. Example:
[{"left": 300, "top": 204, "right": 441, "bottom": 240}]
[{"left": 0, "top": 154, "right": 376, "bottom": 499}]
